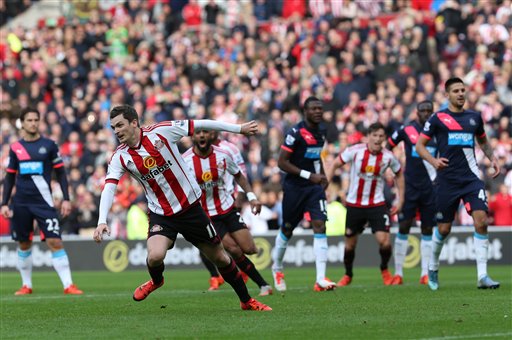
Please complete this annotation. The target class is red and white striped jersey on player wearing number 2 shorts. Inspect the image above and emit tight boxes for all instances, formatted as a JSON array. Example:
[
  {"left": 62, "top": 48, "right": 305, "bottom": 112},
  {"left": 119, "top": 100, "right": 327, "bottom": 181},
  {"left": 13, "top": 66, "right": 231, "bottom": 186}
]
[{"left": 340, "top": 144, "right": 401, "bottom": 207}]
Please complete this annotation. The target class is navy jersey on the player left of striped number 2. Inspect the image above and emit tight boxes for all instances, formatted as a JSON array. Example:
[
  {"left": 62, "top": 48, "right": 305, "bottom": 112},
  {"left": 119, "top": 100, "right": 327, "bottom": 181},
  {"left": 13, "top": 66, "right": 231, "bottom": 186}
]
[{"left": 281, "top": 121, "right": 326, "bottom": 186}]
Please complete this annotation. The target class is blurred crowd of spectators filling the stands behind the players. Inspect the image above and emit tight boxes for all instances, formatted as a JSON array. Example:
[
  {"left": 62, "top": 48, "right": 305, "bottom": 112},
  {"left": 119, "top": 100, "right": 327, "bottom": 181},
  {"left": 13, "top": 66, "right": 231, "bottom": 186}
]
[{"left": 0, "top": 0, "right": 512, "bottom": 239}]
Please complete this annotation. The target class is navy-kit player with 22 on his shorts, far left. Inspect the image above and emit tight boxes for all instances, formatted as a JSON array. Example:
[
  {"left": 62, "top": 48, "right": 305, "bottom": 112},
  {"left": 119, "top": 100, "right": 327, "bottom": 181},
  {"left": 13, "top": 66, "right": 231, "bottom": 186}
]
[{"left": 1, "top": 108, "right": 83, "bottom": 295}]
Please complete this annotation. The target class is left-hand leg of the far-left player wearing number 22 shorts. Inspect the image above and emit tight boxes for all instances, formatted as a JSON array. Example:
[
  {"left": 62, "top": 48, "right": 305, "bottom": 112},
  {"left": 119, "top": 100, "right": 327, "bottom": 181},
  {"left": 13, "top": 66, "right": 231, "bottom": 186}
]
[{"left": 11, "top": 204, "right": 34, "bottom": 295}]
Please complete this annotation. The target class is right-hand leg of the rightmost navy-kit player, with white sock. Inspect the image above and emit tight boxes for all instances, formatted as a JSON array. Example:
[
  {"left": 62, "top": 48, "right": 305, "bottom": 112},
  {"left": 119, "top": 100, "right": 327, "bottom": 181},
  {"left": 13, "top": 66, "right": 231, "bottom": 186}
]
[{"left": 463, "top": 187, "right": 500, "bottom": 289}]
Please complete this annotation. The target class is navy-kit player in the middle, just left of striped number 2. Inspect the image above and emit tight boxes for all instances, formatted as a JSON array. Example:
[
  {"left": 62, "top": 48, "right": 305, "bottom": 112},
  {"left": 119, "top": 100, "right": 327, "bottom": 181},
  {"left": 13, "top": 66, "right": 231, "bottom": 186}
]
[{"left": 272, "top": 97, "right": 336, "bottom": 292}]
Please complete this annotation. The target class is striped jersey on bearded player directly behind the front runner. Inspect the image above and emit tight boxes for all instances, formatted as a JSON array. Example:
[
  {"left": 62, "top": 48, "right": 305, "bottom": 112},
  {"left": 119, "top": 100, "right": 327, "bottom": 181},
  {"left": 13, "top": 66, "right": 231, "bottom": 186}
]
[{"left": 183, "top": 145, "right": 241, "bottom": 216}]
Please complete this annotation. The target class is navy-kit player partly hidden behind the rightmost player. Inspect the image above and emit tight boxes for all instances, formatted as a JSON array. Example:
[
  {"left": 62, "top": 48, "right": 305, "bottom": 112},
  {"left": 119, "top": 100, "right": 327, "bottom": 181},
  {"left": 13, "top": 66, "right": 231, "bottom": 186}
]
[{"left": 387, "top": 100, "right": 437, "bottom": 285}]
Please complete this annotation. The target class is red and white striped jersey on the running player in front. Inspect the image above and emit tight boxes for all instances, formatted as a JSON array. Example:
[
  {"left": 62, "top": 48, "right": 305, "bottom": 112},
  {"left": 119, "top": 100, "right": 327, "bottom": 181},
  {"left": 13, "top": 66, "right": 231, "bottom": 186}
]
[{"left": 105, "top": 120, "right": 201, "bottom": 216}]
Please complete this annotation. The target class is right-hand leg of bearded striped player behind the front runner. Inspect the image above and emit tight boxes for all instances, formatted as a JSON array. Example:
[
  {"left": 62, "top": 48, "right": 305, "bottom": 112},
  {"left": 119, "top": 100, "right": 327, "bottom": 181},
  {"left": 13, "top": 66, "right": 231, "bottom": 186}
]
[{"left": 222, "top": 228, "right": 272, "bottom": 296}]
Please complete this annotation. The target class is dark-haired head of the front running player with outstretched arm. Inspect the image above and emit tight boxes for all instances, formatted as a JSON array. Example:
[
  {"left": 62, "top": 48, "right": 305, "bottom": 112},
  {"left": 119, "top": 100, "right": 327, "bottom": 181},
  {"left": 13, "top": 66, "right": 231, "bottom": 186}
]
[{"left": 110, "top": 105, "right": 139, "bottom": 146}]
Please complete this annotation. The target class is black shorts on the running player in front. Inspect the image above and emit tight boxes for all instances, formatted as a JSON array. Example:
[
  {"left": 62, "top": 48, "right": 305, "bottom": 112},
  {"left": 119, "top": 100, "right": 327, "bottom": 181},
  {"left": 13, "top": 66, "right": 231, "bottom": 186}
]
[{"left": 148, "top": 204, "right": 220, "bottom": 246}]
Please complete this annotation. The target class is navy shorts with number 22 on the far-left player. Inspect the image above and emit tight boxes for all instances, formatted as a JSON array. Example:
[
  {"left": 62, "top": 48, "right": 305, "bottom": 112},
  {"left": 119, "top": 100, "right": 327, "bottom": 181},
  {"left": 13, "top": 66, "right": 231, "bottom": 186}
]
[{"left": 11, "top": 204, "right": 61, "bottom": 242}]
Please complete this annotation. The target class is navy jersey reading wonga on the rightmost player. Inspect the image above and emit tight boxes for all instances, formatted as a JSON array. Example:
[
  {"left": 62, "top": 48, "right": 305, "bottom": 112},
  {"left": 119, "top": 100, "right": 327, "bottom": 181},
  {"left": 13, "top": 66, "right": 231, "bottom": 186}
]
[{"left": 422, "top": 109, "right": 485, "bottom": 184}]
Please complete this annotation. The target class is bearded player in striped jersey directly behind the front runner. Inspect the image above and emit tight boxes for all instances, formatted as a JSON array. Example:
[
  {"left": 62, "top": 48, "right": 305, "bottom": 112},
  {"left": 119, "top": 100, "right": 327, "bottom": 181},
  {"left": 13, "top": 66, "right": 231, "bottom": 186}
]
[{"left": 183, "top": 129, "right": 272, "bottom": 296}]
